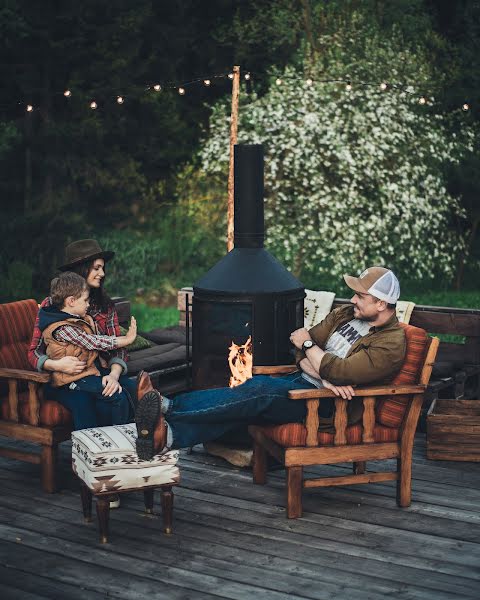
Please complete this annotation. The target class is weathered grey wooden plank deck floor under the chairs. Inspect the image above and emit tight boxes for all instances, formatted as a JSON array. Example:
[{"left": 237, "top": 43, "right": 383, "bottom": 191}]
[{"left": 0, "top": 436, "right": 480, "bottom": 600}]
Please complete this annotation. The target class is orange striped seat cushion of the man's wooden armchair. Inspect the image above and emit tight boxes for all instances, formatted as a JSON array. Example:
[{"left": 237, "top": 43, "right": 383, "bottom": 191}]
[{"left": 262, "top": 423, "right": 399, "bottom": 448}]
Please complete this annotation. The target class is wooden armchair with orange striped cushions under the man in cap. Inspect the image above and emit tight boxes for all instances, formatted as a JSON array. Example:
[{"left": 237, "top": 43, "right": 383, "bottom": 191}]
[{"left": 249, "top": 324, "right": 439, "bottom": 519}]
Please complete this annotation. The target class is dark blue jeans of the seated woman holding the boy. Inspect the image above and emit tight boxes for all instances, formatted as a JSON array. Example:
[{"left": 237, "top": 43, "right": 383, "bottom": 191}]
[{"left": 45, "top": 368, "right": 137, "bottom": 429}]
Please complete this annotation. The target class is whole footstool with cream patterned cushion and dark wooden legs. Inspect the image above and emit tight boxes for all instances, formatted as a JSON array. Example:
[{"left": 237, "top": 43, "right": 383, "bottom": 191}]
[{"left": 72, "top": 423, "right": 180, "bottom": 543}]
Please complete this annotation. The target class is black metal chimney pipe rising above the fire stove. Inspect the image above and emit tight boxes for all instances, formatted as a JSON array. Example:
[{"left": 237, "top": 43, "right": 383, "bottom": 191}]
[{"left": 233, "top": 144, "right": 265, "bottom": 248}]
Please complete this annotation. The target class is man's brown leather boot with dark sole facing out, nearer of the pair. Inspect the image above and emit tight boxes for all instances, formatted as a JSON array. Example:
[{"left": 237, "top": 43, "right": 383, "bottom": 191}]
[{"left": 135, "top": 389, "right": 167, "bottom": 460}]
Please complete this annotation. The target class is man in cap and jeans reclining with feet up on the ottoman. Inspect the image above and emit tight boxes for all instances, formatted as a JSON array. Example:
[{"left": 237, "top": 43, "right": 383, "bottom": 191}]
[{"left": 136, "top": 267, "right": 406, "bottom": 460}]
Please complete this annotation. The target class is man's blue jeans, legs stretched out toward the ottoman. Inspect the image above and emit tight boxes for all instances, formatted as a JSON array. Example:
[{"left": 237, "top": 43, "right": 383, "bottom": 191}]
[{"left": 165, "top": 373, "right": 333, "bottom": 448}]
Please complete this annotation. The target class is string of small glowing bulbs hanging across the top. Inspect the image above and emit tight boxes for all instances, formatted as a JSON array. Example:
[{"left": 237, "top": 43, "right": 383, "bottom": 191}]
[{"left": 13, "top": 71, "right": 471, "bottom": 113}]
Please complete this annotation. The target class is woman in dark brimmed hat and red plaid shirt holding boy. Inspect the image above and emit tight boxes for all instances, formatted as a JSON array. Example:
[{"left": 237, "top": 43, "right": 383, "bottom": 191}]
[{"left": 28, "top": 240, "right": 136, "bottom": 429}]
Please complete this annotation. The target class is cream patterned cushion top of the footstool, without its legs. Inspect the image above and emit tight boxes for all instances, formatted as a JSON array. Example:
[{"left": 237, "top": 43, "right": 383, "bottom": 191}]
[{"left": 72, "top": 423, "right": 180, "bottom": 493}]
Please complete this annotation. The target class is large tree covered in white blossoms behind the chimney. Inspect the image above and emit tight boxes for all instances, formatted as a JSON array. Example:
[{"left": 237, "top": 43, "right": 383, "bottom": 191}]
[{"left": 201, "top": 31, "right": 473, "bottom": 282}]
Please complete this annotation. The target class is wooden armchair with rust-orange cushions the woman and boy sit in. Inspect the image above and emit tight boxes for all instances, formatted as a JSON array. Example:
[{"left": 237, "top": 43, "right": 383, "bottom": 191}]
[{"left": 0, "top": 300, "right": 72, "bottom": 492}]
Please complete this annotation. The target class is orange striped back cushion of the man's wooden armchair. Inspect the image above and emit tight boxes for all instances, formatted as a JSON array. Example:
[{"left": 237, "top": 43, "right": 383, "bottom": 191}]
[{"left": 375, "top": 323, "right": 429, "bottom": 428}]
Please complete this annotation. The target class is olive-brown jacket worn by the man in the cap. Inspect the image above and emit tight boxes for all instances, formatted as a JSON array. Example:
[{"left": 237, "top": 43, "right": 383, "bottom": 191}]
[{"left": 296, "top": 304, "right": 406, "bottom": 423}]
